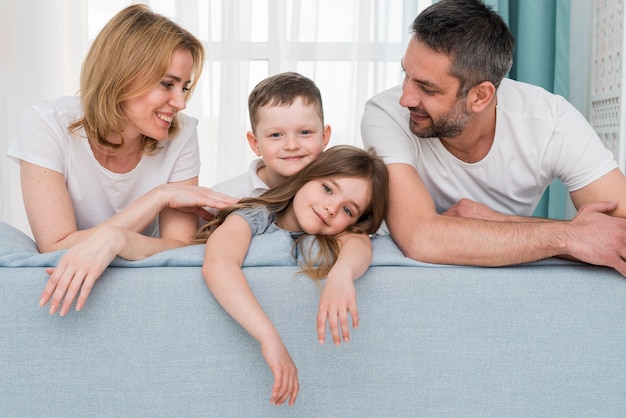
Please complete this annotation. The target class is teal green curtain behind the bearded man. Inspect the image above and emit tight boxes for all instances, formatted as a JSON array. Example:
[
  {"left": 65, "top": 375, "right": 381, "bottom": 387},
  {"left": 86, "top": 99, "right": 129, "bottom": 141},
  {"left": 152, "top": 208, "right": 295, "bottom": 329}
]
[{"left": 485, "top": 0, "right": 571, "bottom": 219}]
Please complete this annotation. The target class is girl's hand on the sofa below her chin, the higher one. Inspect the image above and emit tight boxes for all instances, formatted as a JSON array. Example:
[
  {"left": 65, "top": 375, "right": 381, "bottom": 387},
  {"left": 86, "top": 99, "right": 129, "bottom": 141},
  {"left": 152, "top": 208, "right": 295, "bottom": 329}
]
[{"left": 317, "top": 271, "right": 359, "bottom": 345}]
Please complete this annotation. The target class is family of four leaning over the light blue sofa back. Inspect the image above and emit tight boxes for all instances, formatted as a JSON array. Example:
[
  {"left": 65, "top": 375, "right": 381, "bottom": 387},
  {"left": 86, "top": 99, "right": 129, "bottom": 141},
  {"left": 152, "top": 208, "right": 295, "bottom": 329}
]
[{"left": 8, "top": 0, "right": 626, "bottom": 405}]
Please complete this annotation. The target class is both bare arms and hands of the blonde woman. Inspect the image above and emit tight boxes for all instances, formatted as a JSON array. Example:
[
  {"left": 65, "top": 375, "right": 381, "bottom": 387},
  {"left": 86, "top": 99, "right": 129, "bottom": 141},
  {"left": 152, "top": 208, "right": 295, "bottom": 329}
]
[{"left": 20, "top": 161, "right": 236, "bottom": 315}]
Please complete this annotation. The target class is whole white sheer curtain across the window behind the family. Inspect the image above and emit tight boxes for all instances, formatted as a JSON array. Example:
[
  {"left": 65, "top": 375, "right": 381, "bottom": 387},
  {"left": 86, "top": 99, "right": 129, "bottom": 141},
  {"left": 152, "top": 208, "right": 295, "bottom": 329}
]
[{"left": 0, "top": 0, "right": 431, "bottom": 233}]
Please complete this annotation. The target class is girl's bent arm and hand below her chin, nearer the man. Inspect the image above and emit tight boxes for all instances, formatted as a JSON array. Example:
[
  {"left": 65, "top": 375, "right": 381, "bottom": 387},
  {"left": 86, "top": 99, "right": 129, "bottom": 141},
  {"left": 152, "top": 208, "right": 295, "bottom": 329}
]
[{"left": 317, "top": 233, "right": 372, "bottom": 345}]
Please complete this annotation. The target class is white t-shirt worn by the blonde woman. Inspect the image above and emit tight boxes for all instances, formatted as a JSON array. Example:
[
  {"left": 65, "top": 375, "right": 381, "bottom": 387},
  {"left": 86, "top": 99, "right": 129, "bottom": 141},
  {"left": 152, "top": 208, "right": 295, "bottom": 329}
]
[{"left": 7, "top": 96, "right": 200, "bottom": 236}]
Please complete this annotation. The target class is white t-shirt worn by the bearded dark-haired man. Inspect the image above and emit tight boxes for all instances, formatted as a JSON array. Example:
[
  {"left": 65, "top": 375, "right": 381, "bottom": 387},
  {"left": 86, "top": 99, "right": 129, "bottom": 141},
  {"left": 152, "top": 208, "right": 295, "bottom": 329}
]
[{"left": 361, "top": 79, "right": 617, "bottom": 216}]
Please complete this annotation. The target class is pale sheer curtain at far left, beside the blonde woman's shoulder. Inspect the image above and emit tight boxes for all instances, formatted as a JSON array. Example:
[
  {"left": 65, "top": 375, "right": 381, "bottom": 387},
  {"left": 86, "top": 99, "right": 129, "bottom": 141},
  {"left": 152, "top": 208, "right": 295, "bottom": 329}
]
[{"left": 0, "top": 0, "right": 88, "bottom": 234}]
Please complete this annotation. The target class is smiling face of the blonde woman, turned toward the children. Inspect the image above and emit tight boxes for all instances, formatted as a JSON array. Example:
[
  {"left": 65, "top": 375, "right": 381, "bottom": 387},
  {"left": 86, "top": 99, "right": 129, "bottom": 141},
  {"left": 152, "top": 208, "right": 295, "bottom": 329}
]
[{"left": 123, "top": 49, "right": 193, "bottom": 141}]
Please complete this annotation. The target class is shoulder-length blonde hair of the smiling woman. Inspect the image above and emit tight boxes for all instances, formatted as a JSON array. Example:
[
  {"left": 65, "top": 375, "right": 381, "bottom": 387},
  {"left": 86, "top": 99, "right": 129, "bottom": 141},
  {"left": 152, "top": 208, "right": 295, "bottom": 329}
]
[{"left": 68, "top": 4, "right": 204, "bottom": 153}]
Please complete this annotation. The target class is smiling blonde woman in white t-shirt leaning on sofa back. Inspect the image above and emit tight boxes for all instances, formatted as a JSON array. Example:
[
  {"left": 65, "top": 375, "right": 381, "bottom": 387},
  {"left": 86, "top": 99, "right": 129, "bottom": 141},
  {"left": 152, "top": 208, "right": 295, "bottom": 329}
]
[{"left": 8, "top": 4, "right": 235, "bottom": 315}]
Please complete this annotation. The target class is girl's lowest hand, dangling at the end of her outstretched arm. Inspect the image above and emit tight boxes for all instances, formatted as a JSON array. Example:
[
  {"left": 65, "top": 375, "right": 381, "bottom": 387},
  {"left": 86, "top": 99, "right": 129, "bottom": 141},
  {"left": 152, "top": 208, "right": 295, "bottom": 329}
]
[{"left": 261, "top": 338, "right": 300, "bottom": 406}]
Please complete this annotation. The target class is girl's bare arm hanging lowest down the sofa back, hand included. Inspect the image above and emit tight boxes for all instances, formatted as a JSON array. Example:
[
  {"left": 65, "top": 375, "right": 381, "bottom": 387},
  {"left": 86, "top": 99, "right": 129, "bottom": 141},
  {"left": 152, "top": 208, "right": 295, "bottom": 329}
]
[{"left": 202, "top": 215, "right": 299, "bottom": 406}]
